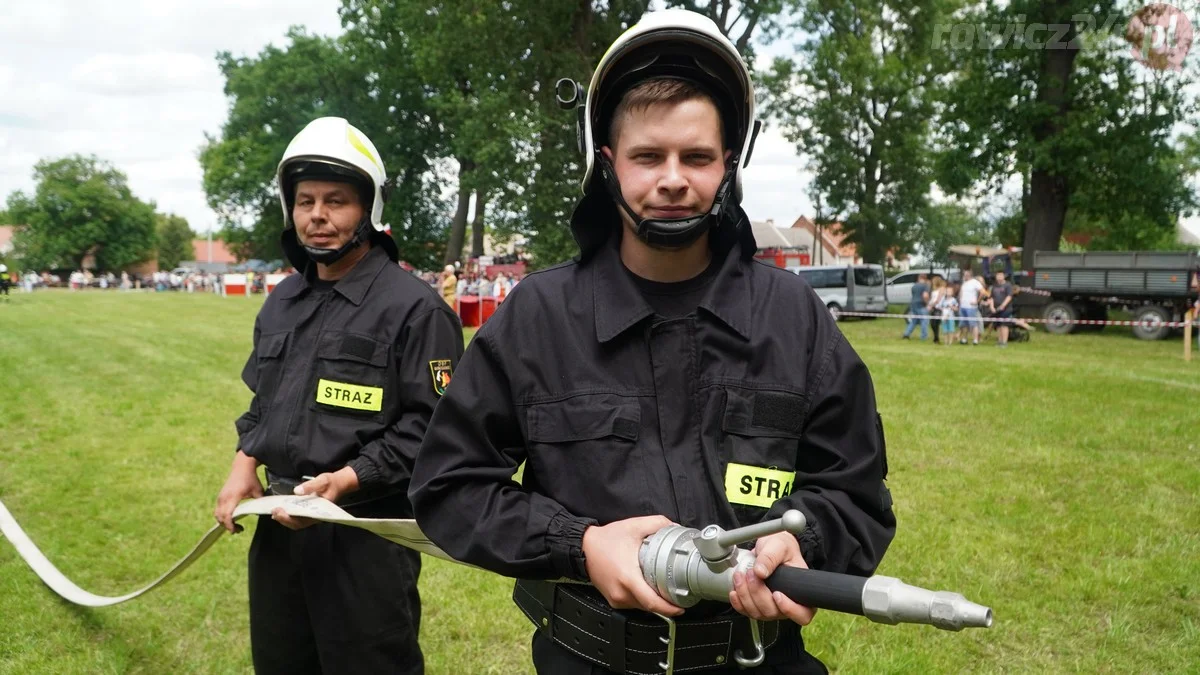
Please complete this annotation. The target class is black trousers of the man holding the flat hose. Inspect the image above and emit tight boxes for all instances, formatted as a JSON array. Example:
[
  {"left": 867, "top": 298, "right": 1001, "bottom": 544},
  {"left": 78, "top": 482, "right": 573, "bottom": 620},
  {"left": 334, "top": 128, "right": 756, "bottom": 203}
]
[{"left": 250, "top": 500, "right": 425, "bottom": 675}]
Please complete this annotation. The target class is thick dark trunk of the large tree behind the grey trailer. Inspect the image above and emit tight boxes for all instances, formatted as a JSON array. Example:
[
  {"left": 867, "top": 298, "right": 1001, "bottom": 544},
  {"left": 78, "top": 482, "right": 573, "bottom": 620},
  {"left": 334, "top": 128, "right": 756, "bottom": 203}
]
[{"left": 1021, "top": 22, "right": 1079, "bottom": 269}]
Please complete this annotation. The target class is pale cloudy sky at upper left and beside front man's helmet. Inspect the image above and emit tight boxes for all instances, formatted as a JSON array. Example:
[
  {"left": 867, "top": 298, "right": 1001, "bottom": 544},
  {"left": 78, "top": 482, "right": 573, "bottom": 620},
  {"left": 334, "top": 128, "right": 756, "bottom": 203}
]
[{"left": 0, "top": 0, "right": 811, "bottom": 232}]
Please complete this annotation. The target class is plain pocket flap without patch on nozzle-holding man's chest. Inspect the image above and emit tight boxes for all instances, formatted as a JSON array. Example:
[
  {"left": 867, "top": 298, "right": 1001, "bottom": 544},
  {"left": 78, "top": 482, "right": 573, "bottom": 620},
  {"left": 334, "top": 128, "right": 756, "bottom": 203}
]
[{"left": 527, "top": 394, "right": 642, "bottom": 443}]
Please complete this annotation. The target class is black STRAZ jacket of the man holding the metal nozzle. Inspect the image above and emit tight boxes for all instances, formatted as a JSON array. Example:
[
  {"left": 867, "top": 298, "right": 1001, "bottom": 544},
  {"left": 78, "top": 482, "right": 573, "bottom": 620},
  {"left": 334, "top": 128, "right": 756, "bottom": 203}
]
[{"left": 409, "top": 236, "right": 895, "bottom": 579}]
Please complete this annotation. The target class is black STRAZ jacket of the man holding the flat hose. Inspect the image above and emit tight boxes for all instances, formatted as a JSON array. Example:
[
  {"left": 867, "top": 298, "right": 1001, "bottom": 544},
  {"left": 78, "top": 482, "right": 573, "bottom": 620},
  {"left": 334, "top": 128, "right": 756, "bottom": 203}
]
[{"left": 236, "top": 246, "right": 462, "bottom": 494}]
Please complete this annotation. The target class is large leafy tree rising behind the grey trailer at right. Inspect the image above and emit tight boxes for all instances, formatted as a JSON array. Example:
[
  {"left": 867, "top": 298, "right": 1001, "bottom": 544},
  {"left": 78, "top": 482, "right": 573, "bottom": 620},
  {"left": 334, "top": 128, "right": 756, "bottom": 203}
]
[{"left": 937, "top": 0, "right": 1194, "bottom": 268}]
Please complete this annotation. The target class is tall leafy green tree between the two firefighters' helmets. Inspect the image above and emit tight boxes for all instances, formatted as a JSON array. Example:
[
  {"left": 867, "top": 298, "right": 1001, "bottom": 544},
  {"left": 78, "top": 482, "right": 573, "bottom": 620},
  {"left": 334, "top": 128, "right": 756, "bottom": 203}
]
[{"left": 342, "top": 0, "right": 594, "bottom": 263}]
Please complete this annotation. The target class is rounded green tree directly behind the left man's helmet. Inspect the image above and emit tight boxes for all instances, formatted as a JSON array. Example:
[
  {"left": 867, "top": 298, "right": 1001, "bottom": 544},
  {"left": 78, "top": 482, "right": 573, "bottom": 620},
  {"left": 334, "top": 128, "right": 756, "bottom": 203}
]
[{"left": 200, "top": 26, "right": 444, "bottom": 269}]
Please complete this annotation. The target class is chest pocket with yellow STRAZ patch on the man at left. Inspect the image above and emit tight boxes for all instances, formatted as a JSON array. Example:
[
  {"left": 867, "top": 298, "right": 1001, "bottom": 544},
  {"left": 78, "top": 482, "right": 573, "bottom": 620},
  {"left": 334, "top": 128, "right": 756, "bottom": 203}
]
[{"left": 310, "top": 331, "right": 392, "bottom": 419}]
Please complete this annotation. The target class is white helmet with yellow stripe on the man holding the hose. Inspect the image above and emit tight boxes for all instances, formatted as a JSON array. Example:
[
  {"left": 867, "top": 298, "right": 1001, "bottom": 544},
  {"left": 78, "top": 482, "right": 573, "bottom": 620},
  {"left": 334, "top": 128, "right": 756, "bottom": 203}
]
[{"left": 276, "top": 117, "right": 398, "bottom": 269}]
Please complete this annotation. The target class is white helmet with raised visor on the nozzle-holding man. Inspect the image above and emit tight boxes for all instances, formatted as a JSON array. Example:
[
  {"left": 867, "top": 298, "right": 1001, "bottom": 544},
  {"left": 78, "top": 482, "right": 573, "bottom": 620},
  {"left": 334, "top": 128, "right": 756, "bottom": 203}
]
[{"left": 582, "top": 10, "right": 758, "bottom": 202}]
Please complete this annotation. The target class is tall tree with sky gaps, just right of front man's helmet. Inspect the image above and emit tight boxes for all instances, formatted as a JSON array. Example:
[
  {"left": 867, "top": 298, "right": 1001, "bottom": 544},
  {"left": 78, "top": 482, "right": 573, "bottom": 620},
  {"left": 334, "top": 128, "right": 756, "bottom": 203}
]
[{"left": 764, "top": 0, "right": 948, "bottom": 261}]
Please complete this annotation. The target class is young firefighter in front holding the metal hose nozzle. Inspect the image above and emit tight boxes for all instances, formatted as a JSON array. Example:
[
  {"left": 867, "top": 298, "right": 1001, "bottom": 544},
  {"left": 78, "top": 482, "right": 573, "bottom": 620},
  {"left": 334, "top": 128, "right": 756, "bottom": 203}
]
[{"left": 409, "top": 10, "right": 895, "bottom": 675}]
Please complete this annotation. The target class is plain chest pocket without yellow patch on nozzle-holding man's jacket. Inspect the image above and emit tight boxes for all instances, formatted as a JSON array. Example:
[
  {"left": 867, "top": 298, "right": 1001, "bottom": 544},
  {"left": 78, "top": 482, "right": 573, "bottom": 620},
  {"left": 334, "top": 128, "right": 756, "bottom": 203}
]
[{"left": 526, "top": 394, "right": 642, "bottom": 497}]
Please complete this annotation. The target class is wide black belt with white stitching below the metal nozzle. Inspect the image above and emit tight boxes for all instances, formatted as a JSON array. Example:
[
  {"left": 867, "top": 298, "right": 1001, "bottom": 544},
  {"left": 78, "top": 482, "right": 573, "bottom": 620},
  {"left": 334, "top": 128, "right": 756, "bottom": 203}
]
[{"left": 512, "top": 579, "right": 781, "bottom": 675}]
